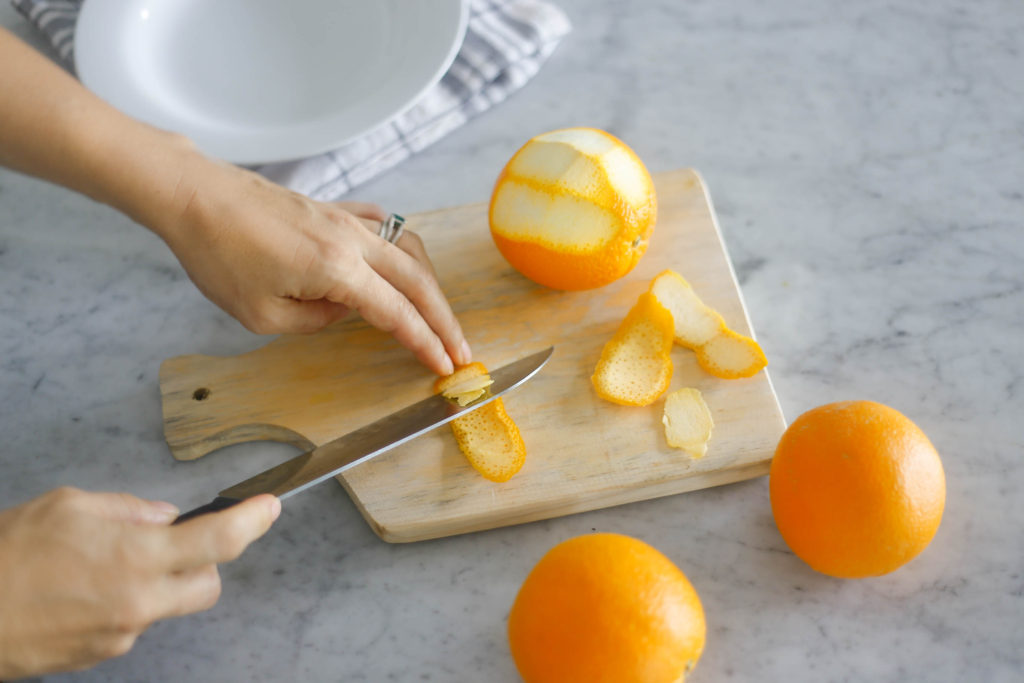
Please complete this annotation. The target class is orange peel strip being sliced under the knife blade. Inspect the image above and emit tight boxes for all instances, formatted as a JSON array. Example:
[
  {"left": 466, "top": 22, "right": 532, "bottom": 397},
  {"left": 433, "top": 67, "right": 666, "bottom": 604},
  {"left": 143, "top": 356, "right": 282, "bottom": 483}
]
[{"left": 434, "top": 362, "right": 526, "bottom": 481}]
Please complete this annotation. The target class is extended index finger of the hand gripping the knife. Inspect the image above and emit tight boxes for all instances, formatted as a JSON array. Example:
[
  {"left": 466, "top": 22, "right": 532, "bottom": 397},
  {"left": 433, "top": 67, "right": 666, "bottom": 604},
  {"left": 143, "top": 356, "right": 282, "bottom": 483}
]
[{"left": 168, "top": 495, "right": 281, "bottom": 571}]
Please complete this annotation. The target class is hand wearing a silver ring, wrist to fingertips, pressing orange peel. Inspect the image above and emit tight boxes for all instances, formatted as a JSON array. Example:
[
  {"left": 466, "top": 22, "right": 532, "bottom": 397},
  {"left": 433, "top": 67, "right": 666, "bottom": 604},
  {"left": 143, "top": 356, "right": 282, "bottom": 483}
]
[{"left": 155, "top": 155, "right": 472, "bottom": 375}]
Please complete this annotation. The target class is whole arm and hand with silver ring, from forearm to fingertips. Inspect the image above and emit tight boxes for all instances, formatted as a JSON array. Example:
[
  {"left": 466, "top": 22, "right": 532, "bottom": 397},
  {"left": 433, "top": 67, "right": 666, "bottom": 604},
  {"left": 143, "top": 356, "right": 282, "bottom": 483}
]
[{"left": 0, "top": 29, "right": 471, "bottom": 375}]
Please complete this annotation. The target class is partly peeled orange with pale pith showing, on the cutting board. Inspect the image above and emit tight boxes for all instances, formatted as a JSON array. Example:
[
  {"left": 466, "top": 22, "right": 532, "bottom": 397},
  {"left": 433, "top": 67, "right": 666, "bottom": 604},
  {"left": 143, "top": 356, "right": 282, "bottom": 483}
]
[{"left": 488, "top": 128, "right": 657, "bottom": 290}]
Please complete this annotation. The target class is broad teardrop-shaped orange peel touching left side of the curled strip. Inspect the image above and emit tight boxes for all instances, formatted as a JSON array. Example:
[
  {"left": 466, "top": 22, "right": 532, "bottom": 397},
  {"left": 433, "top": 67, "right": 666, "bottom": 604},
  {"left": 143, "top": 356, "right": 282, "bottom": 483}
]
[{"left": 591, "top": 292, "right": 673, "bottom": 405}]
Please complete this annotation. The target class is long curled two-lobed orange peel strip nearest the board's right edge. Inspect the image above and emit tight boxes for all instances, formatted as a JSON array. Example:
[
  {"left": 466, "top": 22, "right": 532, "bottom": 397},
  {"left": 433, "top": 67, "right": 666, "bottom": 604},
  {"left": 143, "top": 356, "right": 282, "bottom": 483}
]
[{"left": 648, "top": 270, "right": 768, "bottom": 380}]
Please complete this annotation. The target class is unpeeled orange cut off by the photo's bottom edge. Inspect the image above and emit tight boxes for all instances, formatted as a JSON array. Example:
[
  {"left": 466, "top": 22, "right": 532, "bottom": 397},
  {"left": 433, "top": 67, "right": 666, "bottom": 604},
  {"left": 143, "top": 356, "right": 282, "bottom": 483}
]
[{"left": 509, "top": 533, "right": 706, "bottom": 683}]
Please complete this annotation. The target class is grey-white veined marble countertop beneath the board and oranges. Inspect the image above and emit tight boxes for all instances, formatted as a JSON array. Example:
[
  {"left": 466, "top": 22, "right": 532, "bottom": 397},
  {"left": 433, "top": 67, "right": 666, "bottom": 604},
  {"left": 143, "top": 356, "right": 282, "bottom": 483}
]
[{"left": 0, "top": 0, "right": 1024, "bottom": 681}]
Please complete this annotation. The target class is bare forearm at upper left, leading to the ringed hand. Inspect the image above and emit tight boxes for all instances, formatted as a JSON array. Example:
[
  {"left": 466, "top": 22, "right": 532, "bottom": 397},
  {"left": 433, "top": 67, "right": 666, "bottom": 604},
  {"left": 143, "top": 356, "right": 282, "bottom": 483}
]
[{"left": 0, "top": 29, "right": 200, "bottom": 239}]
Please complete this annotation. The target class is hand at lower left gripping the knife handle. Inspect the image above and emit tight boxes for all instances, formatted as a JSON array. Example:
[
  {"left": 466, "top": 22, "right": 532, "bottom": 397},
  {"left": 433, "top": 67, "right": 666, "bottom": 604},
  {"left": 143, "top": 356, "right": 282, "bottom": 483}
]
[{"left": 0, "top": 488, "right": 281, "bottom": 679}]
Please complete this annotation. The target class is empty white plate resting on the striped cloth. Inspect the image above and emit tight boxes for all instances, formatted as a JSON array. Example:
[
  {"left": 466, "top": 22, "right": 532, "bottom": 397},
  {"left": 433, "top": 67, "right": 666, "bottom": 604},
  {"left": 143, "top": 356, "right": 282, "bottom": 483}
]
[{"left": 75, "top": 0, "right": 468, "bottom": 164}]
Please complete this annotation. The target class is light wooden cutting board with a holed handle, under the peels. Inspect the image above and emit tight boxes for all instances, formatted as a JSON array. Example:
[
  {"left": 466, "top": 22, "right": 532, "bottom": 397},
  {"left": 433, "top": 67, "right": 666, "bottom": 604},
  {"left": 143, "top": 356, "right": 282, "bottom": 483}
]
[{"left": 160, "top": 169, "right": 785, "bottom": 542}]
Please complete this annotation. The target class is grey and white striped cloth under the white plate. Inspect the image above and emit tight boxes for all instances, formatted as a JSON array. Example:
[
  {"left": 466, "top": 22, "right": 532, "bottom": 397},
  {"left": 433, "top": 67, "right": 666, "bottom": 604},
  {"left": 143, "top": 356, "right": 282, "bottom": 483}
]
[{"left": 11, "top": 0, "right": 570, "bottom": 201}]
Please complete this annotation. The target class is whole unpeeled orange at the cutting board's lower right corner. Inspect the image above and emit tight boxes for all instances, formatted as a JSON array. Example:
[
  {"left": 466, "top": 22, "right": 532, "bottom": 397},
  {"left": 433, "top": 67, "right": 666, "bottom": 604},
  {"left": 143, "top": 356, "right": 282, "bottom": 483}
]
[{"left": 769, "top": 400, "right": 946, "bottom": 579}]
